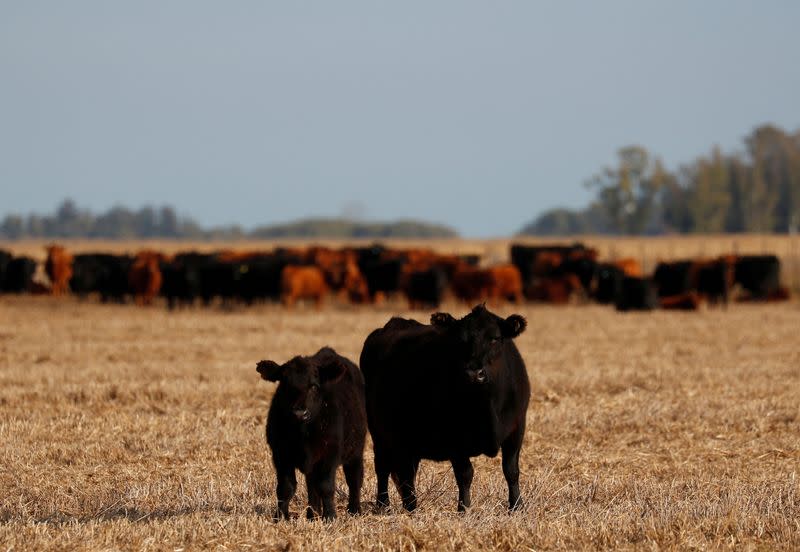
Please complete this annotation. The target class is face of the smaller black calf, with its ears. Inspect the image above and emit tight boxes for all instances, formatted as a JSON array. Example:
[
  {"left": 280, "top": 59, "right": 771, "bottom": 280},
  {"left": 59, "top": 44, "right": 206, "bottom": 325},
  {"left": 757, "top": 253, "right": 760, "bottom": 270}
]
[{"left": 256, "top": 356, "right": 347, "bottom": 424}]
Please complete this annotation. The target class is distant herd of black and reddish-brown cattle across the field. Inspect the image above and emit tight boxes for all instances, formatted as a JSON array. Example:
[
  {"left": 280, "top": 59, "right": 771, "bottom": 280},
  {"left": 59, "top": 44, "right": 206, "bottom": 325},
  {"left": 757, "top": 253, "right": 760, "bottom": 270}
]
[{"left": 0, "top": 243, "right": 789, "bottom": 310}]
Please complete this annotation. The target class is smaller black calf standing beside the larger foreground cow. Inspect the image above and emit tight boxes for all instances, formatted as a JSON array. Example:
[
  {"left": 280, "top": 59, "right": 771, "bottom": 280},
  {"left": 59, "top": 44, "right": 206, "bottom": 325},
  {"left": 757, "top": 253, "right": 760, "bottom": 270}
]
[{"left": 257, "top": 347, "right": 367, "bottom": 519}]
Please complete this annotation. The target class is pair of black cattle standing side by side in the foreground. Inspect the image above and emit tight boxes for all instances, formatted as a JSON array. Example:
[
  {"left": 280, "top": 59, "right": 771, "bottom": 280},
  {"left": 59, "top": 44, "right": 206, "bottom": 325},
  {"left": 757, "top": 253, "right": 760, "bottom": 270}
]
[{"left": 256, "top": 305, "right": 531, "bottom": 520}]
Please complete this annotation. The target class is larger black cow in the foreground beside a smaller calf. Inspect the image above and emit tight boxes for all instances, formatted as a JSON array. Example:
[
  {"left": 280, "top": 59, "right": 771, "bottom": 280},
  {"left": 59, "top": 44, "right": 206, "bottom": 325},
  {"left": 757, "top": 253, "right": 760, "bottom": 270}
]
[{"left": 361, "top": 305, "right": 530, "bottom": 511}]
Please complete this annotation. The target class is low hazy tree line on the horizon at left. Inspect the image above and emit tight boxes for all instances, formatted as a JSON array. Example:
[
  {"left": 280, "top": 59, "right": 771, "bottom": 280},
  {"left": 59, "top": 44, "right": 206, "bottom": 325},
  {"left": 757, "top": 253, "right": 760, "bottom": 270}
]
[{"left": 0, "top": 199, "right": 457, "bottom": 240}]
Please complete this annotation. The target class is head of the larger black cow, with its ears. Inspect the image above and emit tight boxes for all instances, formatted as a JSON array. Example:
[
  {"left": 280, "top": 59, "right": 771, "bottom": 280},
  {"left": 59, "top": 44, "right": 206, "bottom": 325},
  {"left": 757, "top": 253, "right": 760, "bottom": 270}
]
[{"left": 431, "top": 305, "right": 526, "bottom": 385}]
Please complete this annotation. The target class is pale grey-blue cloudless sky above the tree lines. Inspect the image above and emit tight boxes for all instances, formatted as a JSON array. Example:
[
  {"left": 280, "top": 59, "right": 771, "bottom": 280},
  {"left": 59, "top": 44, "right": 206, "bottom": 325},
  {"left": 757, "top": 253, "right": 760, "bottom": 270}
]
[{"left": 0, "top": 0, "right": 800, "bottom": 237}]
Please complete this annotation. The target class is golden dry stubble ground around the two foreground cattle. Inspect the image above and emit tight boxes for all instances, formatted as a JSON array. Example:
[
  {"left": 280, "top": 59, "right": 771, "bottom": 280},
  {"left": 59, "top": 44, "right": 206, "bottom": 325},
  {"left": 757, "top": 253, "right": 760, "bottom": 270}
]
[{"left": 0, "top": 297, "right": 800, "bottom": 550}]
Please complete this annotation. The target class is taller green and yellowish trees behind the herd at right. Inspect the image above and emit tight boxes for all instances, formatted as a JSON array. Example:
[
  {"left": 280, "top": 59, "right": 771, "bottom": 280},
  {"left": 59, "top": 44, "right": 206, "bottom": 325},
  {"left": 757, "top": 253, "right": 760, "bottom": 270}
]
[{"left": 520, "top": 125, "right": 800, "bottom": 235}]
